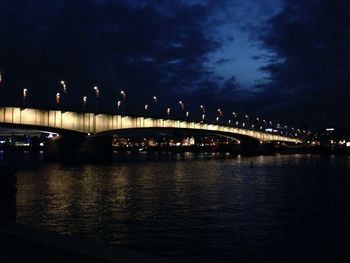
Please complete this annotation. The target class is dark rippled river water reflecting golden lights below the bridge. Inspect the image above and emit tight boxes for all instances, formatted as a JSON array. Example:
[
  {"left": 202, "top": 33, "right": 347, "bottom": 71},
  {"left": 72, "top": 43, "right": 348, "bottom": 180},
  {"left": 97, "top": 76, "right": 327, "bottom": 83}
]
[{"left": 6, "top": 154, "right": 350, "bottom": 262}]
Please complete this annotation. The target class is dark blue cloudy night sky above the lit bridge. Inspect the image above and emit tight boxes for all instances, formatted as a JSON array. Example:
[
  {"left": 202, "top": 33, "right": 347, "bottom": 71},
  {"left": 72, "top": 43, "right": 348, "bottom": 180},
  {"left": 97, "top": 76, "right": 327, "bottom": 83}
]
[{"left": 0, "top": 0, "right": 350, "bottom": 129}]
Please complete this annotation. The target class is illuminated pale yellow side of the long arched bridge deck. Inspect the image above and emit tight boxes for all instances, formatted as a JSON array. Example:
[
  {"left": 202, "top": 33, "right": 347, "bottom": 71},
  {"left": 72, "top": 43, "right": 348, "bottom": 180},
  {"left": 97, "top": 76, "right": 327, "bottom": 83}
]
[{"left": 0, "top": 107, "right": 302, "bottom": 143}]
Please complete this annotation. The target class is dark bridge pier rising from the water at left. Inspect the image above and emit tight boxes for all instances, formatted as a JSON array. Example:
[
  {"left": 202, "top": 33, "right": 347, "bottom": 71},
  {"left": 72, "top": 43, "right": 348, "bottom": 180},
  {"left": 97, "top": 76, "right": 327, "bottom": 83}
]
[{"left": 44, "top": 134, "right": 112, "bottom": 162}]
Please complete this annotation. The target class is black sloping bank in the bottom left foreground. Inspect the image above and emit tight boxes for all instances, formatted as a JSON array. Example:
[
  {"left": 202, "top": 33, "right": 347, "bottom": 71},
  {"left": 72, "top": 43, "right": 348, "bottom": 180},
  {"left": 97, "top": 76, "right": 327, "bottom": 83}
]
[{"left": 0, "top": 223, "right": 168, "bottom": 263}]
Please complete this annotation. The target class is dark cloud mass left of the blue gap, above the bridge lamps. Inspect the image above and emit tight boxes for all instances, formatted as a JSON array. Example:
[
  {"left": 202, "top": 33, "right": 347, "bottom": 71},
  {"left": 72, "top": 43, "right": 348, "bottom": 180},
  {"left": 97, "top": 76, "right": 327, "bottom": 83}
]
[{"left": 0, "top": 0, "right": 219, "bottom": 110}]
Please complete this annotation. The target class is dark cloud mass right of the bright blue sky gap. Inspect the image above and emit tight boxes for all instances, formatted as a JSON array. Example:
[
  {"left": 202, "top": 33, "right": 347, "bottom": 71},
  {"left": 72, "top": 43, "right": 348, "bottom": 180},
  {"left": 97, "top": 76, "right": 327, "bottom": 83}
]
[{"left": 261, "top": 0, "right": 350, "bottom": 127}]
